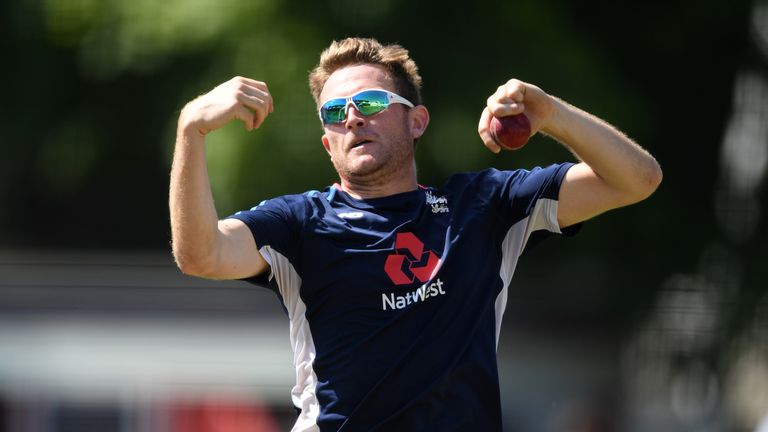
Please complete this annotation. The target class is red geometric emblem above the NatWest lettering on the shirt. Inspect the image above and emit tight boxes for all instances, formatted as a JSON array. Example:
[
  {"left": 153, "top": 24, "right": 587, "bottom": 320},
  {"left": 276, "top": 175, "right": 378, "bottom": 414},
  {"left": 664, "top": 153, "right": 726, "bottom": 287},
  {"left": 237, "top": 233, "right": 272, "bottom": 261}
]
[{"left": 384, "top": 232, "right": 440, "bottom": 285}]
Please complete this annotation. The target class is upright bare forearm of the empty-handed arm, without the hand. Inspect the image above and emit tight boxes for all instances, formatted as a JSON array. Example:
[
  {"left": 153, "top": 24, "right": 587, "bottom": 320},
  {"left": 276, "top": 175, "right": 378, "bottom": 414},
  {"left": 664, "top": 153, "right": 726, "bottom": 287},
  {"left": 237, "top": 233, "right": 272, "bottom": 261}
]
[{"left": 169, "top": 120, "right": 218, "bottom": 274}]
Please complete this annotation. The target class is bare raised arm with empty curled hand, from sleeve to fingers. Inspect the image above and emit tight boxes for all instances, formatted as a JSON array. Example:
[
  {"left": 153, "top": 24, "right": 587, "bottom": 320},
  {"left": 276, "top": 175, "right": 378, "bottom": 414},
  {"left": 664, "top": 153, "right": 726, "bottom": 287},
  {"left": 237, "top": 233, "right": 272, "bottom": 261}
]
[{"left": 169, "top": 77, "right": 273, "bottom": 279}]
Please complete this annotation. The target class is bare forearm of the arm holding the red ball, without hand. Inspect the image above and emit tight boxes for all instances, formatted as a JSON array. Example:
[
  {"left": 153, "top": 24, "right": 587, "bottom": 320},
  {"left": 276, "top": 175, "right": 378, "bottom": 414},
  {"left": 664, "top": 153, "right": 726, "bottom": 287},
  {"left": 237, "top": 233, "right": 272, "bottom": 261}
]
[{"left": 542, "top": 98, "right": 662, "bottom": 201}]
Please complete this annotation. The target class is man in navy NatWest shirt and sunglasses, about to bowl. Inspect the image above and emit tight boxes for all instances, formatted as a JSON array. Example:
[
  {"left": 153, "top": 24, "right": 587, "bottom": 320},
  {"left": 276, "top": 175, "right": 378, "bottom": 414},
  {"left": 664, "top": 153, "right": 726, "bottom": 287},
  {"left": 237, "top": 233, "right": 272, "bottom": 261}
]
[{"left": 170, "top": 38, "right": 661, "bottom": 431}]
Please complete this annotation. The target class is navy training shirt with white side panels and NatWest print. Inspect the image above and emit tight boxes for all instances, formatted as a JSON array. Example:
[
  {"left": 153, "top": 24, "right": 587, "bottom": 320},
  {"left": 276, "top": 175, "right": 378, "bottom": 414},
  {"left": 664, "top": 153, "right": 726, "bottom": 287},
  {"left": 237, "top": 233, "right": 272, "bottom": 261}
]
[{"left": 231, "top": 164, "right": 572, "bottom": 431}]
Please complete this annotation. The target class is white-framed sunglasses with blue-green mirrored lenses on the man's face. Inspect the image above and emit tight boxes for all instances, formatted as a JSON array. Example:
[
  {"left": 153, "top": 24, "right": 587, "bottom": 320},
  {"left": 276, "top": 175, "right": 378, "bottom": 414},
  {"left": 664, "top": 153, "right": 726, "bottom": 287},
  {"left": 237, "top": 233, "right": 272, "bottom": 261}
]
[{"left": 320, "top": 89, "right": 413, "bottom": 125}]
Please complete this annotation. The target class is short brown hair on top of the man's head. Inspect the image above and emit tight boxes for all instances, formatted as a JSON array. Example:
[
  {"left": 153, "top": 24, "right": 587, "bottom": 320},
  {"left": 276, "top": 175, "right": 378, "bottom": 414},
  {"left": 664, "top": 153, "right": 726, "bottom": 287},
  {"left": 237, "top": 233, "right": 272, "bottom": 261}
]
[{"left": 309, "top": 38, "right": 421, "bottom": 105}]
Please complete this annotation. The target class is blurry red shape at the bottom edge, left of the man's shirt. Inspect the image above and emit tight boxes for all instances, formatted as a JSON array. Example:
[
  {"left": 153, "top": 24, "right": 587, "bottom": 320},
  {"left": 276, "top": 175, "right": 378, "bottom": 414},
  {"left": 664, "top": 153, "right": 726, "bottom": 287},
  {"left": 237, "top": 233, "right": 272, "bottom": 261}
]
[{"left": 169, "top": 399, "right": 279, "bottom": 432}]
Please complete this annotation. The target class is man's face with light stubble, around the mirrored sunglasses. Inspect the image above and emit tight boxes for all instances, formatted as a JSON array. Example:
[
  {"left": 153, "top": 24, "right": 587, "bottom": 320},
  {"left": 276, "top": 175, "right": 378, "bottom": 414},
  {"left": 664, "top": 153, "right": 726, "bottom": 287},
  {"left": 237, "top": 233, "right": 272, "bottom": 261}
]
[{"left": 320, "top": 64, "right": 415, "bottom": 183}]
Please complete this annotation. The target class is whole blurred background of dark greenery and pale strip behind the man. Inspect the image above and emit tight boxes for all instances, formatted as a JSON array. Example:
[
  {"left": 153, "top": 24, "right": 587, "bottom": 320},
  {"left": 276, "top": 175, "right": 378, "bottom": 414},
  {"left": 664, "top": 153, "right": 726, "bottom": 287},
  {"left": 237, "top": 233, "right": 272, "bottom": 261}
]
[{"left": 0, "top": 0, "right": 768, "bottom": 432}]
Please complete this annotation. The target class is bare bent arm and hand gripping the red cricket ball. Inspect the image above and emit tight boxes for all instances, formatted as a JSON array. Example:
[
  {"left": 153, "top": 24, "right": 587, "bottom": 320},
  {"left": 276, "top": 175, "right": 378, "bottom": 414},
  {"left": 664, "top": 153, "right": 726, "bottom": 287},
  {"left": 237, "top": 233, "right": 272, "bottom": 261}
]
[{"left": 478, "top": 79, "right": 662, "bottom": 227}]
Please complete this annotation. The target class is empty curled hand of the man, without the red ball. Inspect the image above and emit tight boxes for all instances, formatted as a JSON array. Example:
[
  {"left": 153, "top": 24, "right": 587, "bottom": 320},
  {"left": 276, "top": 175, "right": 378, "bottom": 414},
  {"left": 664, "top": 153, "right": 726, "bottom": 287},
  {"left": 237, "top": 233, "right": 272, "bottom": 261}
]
[{"left": 179, "top": 76, "right": 274, "bottom": 136}]
